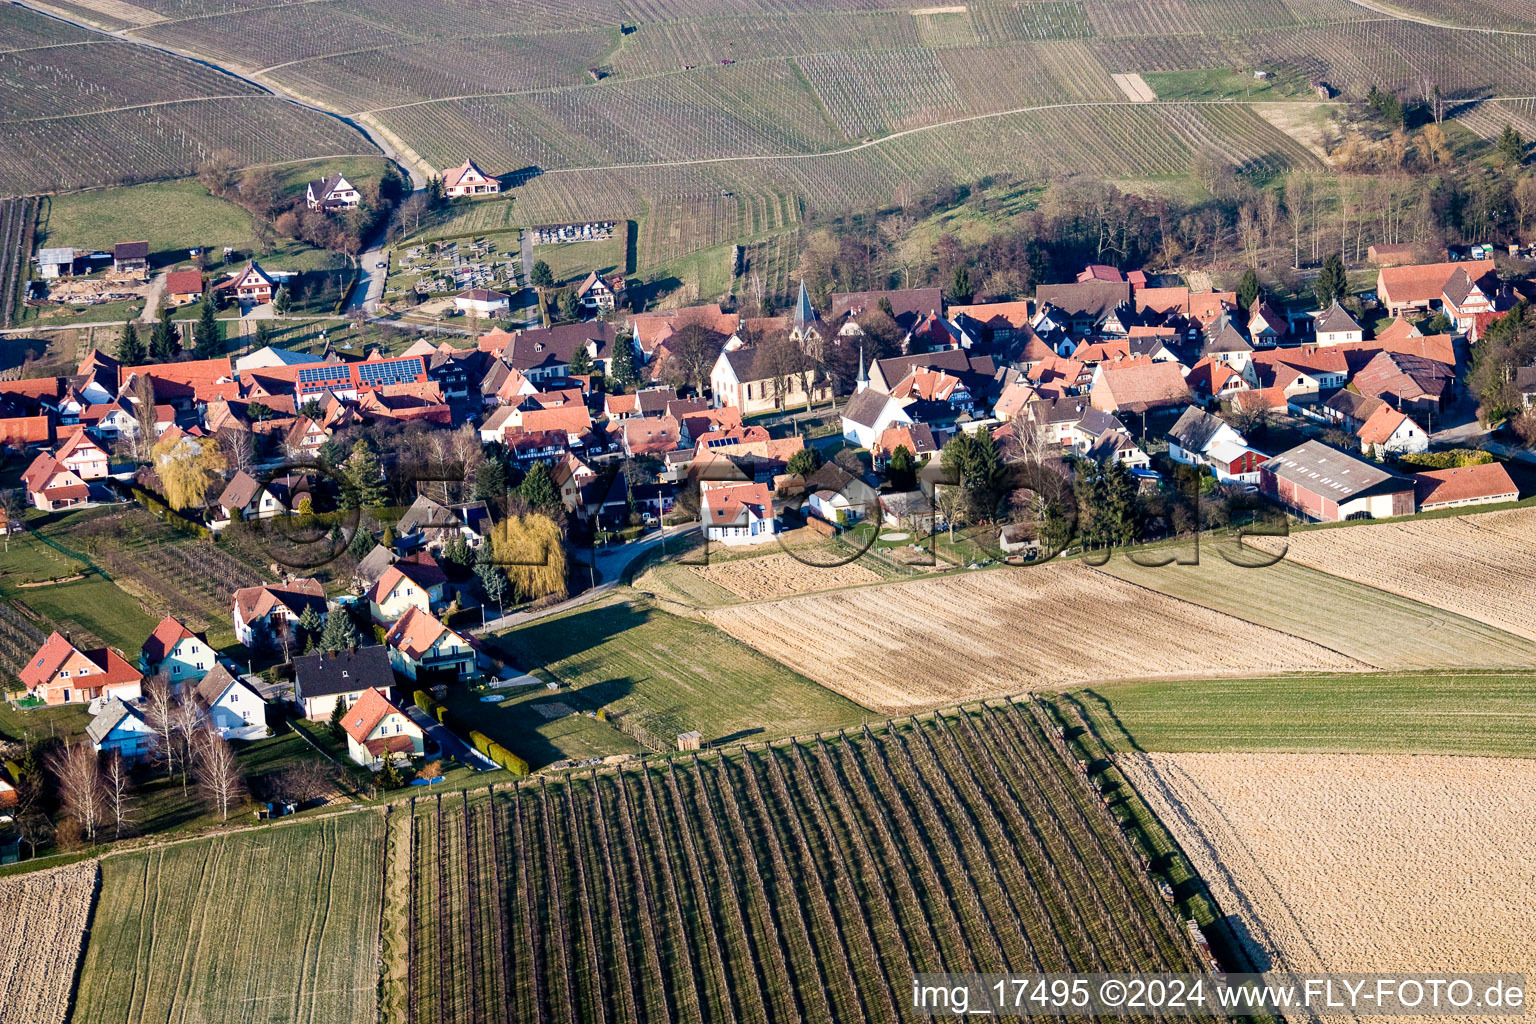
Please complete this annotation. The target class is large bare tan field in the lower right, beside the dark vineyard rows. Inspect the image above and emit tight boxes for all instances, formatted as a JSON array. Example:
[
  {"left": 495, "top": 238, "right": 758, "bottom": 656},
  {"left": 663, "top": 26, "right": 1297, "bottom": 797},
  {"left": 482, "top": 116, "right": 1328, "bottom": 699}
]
[{"left": 1117, "top": 754, "right": 1536, "bottom": 988}]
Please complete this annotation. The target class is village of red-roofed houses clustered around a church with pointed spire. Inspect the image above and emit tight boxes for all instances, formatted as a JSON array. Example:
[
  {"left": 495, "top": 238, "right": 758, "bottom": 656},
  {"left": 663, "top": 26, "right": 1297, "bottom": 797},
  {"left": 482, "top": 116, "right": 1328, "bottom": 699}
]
[{"left": 0, "top": 161, "right": 1536, "bottom": 865}]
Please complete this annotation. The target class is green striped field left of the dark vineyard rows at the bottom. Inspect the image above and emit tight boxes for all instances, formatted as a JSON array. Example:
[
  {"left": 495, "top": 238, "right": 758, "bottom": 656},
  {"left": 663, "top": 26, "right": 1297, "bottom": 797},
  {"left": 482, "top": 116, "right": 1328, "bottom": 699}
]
[{"left": 72, "top": 811, "right": 384, "bottom": 1024}]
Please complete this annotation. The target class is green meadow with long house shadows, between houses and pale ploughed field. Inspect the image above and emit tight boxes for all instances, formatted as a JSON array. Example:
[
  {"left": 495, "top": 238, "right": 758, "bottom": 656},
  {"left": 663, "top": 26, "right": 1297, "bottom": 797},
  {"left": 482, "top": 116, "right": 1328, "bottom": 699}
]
[{"left": 476, "top": 600, "right": 865, "bottom": 757}]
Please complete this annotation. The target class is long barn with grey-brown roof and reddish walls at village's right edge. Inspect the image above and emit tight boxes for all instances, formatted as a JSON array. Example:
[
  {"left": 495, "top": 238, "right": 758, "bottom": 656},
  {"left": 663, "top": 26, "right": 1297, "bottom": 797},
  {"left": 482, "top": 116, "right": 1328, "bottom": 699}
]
[{"left": 1258, "top": 441, "right": 1413, "bottom": 522}]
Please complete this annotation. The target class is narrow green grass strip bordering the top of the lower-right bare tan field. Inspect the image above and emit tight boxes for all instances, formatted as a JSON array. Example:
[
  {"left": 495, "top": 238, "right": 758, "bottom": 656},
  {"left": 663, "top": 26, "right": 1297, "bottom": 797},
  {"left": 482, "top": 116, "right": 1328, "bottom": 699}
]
[{"left": 1068, "top": 672, "right": 1536, "bottom": 757}]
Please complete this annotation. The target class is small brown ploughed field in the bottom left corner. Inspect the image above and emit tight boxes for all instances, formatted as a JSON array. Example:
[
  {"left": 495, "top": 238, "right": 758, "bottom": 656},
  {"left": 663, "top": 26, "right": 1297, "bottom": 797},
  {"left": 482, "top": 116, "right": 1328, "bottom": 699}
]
[{"left": 0, "top": 860, "right": 97, "bottom": 1024}]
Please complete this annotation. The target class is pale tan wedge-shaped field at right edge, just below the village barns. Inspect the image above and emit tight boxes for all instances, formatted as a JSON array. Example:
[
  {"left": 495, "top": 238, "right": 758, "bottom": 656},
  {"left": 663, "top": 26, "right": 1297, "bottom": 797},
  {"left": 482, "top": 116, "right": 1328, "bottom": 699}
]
[{"left": 1253, "top": 508, "right": 1536, "bottom": 640}]
